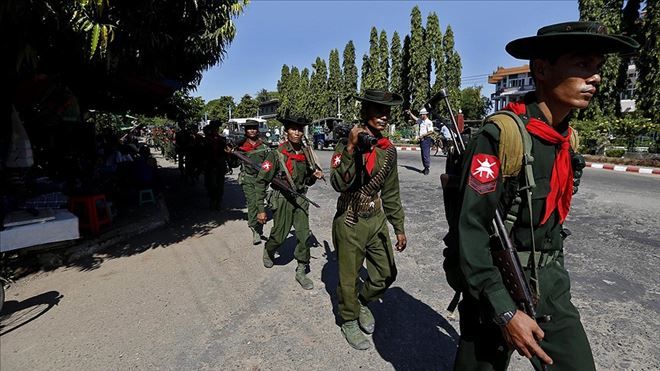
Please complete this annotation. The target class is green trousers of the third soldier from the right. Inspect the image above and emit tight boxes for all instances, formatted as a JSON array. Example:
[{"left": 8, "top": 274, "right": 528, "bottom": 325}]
[{"left": 265, "top": 192, "right": 310, "bottom": 264}]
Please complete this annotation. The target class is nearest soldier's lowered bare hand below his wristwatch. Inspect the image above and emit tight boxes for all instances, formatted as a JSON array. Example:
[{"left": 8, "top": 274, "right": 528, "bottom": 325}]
[{"left": 502, "top": 310, "right": 552, "bottom": 365}]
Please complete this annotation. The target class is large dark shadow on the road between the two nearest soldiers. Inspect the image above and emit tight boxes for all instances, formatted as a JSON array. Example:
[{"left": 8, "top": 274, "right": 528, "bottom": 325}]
[{"left": 369, "top": 287, "right": 459, "bottom": 370}]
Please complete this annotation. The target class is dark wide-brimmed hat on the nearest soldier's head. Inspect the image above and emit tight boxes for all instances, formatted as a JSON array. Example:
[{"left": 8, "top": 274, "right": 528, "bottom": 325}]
[{"left": 506, "top": 22, "right": 639, "bottom": 59}]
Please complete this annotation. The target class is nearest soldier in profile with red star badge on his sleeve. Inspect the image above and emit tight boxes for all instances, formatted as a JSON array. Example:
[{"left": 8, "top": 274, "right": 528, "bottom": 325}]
[{"left": 445, "top": 22, "right": 638, "bottom": 370}]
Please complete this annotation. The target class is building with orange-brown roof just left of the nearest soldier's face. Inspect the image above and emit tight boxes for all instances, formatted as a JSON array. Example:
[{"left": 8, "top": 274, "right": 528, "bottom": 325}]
[{"left": 488, "top": 64, "right": 535, "bottom": 111}]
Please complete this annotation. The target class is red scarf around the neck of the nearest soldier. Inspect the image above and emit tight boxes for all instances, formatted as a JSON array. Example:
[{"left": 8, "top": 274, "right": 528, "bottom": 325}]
[{"left": 504, "top": 103, "right": 573, "bottom": 224}]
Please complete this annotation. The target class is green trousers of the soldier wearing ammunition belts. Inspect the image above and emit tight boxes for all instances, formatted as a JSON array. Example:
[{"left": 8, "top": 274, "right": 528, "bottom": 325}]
[{"left": 332, "top": 210, "right": 397, "bottom": 321}]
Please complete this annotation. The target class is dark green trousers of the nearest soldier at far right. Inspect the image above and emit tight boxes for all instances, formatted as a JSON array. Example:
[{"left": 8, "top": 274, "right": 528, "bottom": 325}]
[{"left": 454, "top": 259, "right": 595, "bottom": 371}]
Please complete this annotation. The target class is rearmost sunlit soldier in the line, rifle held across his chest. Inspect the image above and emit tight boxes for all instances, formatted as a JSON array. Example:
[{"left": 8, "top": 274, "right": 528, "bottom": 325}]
[{"left": 234, "top": 120, "right": 269, "bottom": 245}]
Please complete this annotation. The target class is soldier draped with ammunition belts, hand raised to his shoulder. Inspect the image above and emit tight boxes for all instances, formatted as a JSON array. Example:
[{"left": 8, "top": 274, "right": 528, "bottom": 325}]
[{"left": 331, "top": 89, "right": 407, "bottom": 350}]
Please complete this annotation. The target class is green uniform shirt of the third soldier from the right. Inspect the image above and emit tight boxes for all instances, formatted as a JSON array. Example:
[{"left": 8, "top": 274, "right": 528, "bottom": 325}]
[{"left": 255, "top": 142, "right": 316, "bottom": 213}]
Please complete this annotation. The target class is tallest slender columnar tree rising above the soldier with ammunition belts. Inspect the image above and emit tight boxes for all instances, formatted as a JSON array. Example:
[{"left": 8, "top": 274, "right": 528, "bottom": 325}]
[{"left": 409, "top": 6, "right": 430, "bottom": 109}]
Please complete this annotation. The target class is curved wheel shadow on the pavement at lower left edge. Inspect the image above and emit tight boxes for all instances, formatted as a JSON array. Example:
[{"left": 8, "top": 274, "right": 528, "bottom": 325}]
[{"left": 0, "top": 291, "right": 63, "bottom": 336}]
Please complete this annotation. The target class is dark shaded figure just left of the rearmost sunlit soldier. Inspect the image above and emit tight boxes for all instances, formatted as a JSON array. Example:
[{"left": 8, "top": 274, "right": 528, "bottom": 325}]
[{"left": 203, "top": 120, "right": 228, "bottom": 210}]
